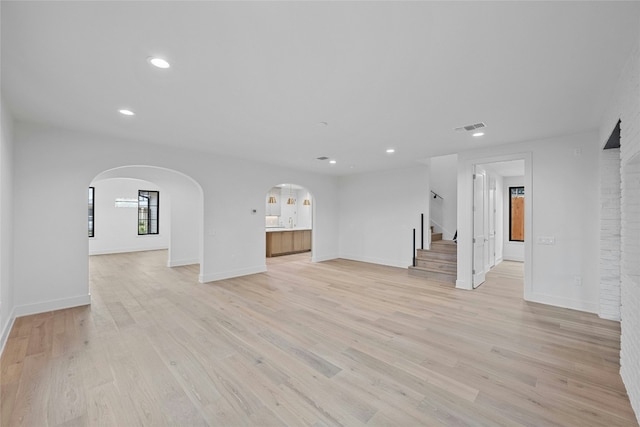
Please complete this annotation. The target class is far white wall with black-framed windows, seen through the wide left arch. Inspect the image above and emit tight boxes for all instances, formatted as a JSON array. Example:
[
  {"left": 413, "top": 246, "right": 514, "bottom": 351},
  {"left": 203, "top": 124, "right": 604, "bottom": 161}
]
[{"left": 89, "top": 178, "right": 172, "bottom": 255}]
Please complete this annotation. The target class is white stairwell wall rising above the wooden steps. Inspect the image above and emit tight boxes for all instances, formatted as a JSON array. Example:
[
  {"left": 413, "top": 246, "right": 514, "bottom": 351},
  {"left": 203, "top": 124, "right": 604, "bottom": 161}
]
[{"left": 429, "top": 154, "right": 458, "bottom": 240}]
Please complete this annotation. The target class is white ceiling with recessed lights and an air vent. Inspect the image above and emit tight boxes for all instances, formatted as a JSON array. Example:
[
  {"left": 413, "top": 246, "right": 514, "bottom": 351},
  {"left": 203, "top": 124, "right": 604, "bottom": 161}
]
[{"left": 1, "top": 1, "right": 640, "bottom": 175}]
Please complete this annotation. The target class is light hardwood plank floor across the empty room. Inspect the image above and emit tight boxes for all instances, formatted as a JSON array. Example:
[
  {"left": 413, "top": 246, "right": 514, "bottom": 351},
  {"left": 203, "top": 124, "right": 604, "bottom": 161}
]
[{"left": 0, "top": 251, "right": 637, "bottom": 427}]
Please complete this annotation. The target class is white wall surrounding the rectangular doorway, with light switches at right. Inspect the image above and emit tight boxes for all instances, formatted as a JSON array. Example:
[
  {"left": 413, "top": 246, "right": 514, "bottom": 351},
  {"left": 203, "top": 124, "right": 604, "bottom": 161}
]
[{"left": 456, "top": 132, "right": 599, "bottom": 312}]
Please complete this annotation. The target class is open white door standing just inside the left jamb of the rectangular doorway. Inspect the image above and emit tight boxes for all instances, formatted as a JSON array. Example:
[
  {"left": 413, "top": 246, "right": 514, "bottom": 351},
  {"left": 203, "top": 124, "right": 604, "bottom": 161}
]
[{"left": 473, "top": 168, "right": 488, "bottom": 288}]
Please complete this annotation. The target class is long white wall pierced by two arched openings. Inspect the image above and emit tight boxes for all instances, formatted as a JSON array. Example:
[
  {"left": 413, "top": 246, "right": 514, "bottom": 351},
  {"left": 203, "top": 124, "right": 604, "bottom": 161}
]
[{"left": 14, "top": 123, "right": 338, "bottom": 315}]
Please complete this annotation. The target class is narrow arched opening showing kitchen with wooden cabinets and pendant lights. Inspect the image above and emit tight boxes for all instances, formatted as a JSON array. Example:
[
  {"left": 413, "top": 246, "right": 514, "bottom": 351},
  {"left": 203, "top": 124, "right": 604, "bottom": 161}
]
[{"left": 265, "top": 183, "right": 314, "bottom": 261}]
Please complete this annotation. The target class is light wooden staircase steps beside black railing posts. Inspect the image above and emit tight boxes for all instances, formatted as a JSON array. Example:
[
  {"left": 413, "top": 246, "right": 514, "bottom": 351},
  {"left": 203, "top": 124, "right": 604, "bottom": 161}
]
[{"left": 409, "top": 227, "right": 458, "bottom": 283}]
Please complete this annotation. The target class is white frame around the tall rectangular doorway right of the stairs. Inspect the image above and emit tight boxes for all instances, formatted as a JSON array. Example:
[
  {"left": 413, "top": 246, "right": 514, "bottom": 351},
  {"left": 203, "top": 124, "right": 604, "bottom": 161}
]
[{"left": 456, "top": 151, "right": 535, "bottom": 300}]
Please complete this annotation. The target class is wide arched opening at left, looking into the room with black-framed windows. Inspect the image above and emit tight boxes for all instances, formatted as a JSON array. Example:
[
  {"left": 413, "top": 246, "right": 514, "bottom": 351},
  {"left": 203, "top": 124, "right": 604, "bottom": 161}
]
[{"left": 89, "top": 165, "right": 204, "bottom": 284}]
